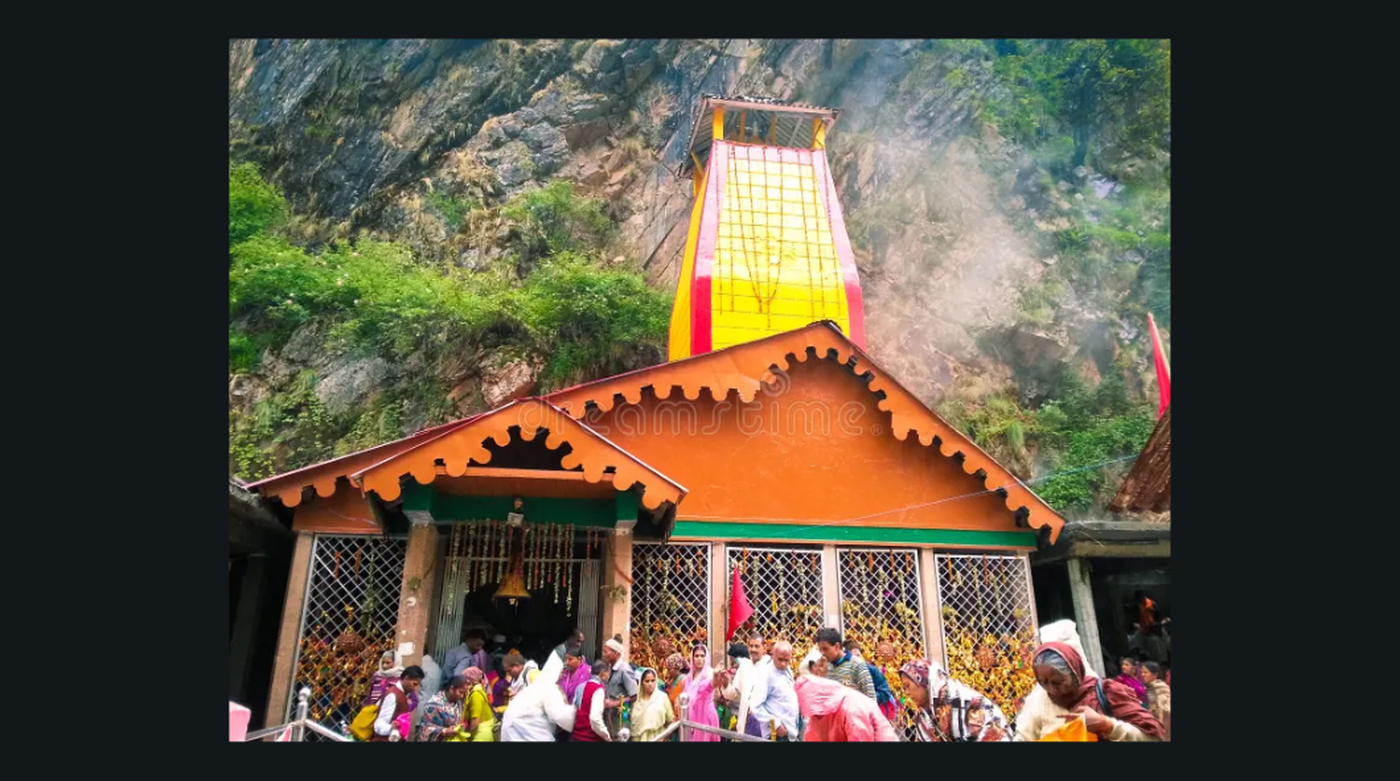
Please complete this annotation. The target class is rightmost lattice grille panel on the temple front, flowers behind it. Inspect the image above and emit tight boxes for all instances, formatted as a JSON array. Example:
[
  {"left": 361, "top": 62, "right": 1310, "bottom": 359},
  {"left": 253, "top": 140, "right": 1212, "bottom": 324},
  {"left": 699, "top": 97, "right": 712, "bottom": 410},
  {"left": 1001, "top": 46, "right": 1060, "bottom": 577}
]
[{"left": 934, "top": 553, "right": 1036, "bottom": 721}]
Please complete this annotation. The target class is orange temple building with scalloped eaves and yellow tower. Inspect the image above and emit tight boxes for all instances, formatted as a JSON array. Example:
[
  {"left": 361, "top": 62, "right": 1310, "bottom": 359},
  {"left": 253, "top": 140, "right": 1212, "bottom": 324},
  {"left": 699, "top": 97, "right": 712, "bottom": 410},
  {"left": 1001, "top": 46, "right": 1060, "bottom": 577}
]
[{"left": 240, "top": 97, "right": 1064, "bottom": 726}]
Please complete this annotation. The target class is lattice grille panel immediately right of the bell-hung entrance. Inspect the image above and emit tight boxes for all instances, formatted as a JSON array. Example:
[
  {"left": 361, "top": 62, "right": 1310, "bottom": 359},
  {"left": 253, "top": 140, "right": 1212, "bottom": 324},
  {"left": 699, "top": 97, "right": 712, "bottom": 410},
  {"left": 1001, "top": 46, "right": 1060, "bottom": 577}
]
[{"left": 629, "top": 542, "right": 710, "bottom": 670}]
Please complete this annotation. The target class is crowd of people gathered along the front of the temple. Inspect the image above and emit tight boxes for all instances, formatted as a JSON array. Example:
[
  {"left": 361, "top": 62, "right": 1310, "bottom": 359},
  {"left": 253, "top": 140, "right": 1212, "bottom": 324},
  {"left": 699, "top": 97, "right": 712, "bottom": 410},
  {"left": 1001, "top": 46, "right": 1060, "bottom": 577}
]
[{"left": 353, "top": 621, "right": 1170, "bottom": 743}]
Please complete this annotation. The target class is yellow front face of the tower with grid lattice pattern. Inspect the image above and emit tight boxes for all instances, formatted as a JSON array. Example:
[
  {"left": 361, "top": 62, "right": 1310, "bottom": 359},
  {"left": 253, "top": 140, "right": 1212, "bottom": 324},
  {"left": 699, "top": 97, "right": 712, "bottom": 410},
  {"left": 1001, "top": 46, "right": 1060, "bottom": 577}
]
[{"left": 711, "top": 147, "right": 850, "bottom": 350}]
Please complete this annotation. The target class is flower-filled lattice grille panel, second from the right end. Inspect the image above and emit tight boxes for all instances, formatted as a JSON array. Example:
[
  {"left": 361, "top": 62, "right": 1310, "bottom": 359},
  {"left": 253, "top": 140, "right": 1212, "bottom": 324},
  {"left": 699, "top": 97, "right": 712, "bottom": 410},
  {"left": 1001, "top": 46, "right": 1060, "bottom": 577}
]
[{"left": 836, "top": 549, "right": 924, "bottom": 739}]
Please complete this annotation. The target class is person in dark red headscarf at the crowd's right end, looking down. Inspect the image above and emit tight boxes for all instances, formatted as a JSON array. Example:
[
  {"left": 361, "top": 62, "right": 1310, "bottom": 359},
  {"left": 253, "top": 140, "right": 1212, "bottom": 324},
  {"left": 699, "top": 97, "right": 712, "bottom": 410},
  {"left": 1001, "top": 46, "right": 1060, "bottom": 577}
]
[{"left": 1015, "top": 642, "right": 1166, "bottom": 742}]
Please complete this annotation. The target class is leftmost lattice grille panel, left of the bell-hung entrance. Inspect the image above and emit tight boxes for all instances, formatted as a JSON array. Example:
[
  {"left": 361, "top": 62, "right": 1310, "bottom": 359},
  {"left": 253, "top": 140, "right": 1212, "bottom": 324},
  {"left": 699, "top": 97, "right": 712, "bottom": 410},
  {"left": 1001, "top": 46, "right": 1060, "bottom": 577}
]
[{"left": 286, "top": 535, "right": 407, "bottom": 739}]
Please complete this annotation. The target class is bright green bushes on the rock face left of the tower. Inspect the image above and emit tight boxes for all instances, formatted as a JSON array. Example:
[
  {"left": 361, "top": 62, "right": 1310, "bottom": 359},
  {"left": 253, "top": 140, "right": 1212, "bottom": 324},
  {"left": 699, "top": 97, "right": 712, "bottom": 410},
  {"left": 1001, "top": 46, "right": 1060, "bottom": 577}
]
[{"left": 228, "top": 165, "right": 671, "bottom": 479}]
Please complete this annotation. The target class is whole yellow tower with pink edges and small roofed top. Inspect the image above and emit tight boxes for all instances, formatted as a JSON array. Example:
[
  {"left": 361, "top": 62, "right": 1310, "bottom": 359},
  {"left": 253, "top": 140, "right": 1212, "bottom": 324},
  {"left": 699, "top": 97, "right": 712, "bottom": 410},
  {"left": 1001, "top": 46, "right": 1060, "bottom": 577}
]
[{"left": 671, "top": 95, "right": 865, "bottom": 361}]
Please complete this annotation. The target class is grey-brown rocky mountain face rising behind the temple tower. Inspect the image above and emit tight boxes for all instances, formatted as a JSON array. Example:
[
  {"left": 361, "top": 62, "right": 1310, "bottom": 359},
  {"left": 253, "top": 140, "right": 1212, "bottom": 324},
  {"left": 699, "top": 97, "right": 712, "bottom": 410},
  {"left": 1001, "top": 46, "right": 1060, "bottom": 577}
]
[{"left": 228, "top": 39, "right": 1170, "bottom": 515}]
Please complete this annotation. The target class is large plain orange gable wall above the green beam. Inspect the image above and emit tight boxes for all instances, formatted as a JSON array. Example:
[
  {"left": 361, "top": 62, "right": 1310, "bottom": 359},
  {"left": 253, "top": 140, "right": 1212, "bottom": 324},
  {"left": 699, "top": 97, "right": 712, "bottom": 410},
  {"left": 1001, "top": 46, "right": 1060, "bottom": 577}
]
[{"left": 584, "top": 360, "right": 1018, "bottom": 530}]
